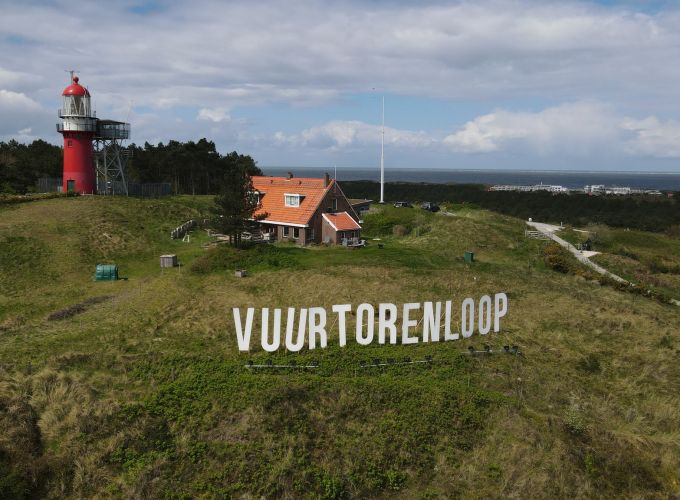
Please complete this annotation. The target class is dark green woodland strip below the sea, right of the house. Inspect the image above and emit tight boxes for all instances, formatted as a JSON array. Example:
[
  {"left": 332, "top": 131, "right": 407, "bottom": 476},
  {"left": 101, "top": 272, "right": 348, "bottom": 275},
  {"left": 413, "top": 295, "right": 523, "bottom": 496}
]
[{"left": 342, "top": 181, "right": 680, "bottom": 231}]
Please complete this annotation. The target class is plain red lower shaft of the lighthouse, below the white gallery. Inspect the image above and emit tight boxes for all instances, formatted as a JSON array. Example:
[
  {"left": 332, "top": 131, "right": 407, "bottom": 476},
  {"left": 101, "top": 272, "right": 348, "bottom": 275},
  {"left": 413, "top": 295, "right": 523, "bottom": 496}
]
[{"left": 63, "top": 132, "right": 96, "bottom": 194}]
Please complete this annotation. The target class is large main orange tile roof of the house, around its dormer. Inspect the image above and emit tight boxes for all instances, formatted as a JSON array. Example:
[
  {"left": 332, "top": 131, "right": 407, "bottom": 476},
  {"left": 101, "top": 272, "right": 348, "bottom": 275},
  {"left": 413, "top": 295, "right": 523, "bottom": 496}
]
[{"left": 251, "top": 176, "right": 335, "bottom": 225}]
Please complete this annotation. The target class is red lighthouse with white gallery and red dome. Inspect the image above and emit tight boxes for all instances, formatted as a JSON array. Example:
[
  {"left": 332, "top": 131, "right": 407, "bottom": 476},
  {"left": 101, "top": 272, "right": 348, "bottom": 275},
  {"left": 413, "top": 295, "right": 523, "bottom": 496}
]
[{"left": 57, "top": 75, "right": 97, "bottom": 194}]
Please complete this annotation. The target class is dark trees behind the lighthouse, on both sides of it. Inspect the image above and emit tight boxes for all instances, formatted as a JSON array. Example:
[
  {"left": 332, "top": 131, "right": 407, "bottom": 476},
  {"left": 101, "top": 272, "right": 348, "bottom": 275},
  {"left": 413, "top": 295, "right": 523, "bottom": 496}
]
[{"left": 0, "top": 139, "right": 262, "bottom": 194}]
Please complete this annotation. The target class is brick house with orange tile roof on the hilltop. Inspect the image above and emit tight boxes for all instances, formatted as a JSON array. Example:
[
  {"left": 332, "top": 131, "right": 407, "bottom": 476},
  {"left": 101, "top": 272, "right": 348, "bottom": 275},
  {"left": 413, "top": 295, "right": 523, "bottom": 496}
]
[{"left": 251, "top": 174, "right": 361, "bottom": 245}]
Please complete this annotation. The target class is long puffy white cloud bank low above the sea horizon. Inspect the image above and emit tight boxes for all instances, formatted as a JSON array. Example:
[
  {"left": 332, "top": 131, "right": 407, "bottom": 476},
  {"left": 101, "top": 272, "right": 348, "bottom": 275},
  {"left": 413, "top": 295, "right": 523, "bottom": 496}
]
[{"left": 273, "top": 101, "right": 680, "bottom": 158}]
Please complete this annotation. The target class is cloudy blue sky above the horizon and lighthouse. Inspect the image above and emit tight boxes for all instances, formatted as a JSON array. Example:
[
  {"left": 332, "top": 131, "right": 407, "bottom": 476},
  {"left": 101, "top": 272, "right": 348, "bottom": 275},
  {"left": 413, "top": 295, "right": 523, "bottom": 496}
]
[{"left": 0, "top": 0, "right": 680, "bottom": 172}]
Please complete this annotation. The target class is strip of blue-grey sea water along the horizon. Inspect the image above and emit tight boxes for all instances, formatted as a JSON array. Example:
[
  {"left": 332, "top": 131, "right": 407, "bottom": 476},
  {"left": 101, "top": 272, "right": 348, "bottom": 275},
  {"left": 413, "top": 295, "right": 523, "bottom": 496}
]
[{"left": 261, "top": 167, "right": 680, "bottom": 191}]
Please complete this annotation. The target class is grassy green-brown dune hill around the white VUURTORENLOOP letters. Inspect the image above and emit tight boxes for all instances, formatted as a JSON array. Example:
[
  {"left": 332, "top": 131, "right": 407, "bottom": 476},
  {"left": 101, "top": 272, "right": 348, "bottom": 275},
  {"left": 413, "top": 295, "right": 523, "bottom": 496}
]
[{"left": 0, "top": 197, "right": 680, "bottom": 498}]
